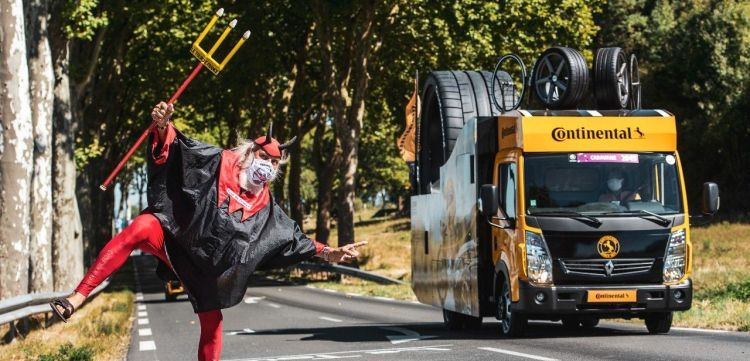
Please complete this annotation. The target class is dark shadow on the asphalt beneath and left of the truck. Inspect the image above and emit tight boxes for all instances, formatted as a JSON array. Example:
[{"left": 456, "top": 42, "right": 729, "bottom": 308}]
[{"left": 235, "top": 322, "right": 647, "bottom": 342}]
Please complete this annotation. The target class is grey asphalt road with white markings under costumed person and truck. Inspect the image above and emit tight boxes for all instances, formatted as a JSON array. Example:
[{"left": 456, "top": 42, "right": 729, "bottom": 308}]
[{"left": 127, "top": 256, "right": 750, "bottom": 361}]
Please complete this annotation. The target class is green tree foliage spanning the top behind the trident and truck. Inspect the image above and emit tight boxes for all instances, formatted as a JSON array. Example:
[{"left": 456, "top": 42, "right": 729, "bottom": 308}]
[{"left": 69, "top": 0, "right": 750, "bottom": 228}]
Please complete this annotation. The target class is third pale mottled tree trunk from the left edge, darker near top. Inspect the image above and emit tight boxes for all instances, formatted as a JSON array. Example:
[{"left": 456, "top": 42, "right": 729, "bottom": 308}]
[{"left": 50, "top": 22, "right": 83, "bottom": 291}]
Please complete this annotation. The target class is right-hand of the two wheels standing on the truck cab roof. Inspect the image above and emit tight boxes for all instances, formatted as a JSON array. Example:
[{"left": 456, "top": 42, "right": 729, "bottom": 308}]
[{"left": 594, "top": 48, "right": 630, "bottom": 109}]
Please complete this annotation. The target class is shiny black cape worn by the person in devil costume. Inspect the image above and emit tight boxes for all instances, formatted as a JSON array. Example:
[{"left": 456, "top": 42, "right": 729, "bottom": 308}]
[{"left": 146, "top": 129, "right": 315, "bottom": 313}]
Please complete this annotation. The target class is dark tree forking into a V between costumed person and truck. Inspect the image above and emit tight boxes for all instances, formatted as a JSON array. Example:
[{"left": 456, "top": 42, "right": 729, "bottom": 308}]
[{"left": 313, "top": 1, "right": 400, "bottom": 253}]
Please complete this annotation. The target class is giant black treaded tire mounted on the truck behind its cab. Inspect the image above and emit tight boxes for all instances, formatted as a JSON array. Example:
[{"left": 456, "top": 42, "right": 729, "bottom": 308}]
[{"left": 419, "top": 70, "right": 517, "bottom": 194}]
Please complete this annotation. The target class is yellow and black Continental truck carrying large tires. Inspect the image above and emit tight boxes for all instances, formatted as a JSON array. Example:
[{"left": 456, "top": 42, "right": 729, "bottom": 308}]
[{"left": 407, "top": 47, "right": 719, "bottom": 336}]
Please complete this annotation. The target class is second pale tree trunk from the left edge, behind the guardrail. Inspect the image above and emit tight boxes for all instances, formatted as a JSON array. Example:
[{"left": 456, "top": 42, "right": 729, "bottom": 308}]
[{"left": 26, "top": 0, "right": 55, "bottom": 292}]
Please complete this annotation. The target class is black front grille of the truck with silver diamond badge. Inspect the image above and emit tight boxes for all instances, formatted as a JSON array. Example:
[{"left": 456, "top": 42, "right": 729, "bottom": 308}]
[{"left": 560, "top": 258, "right": 654, "bottom": 277}]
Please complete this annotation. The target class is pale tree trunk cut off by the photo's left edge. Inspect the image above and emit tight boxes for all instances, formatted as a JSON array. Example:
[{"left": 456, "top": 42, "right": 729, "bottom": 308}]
[{"left": 0, "top": 0, "right": 33, "bottom": 299}]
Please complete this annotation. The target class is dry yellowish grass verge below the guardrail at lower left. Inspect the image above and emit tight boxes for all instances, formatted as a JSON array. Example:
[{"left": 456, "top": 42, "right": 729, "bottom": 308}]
[{"left": 0, "top": 262, "right": 134, "bottom": 361}]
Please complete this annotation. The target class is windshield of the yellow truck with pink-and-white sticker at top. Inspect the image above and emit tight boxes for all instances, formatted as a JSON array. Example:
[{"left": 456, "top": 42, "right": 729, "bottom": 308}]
[{"left": 524, "top": 153, "right": 682, "bottom": 216}]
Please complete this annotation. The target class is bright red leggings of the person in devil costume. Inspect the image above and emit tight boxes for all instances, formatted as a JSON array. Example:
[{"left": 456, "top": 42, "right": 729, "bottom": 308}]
[{"left": 76, "top": 213, "right": 223, "bottom": 361}]
